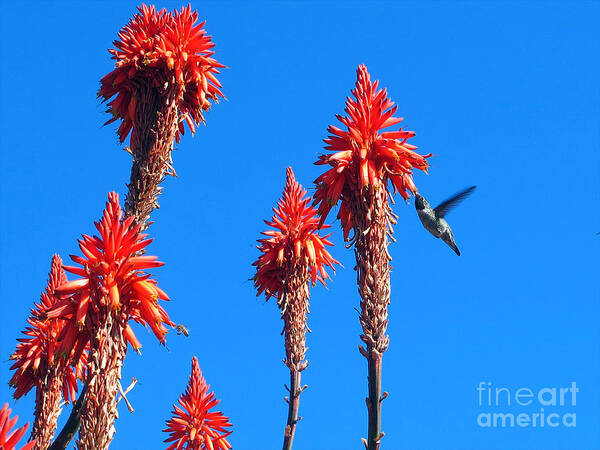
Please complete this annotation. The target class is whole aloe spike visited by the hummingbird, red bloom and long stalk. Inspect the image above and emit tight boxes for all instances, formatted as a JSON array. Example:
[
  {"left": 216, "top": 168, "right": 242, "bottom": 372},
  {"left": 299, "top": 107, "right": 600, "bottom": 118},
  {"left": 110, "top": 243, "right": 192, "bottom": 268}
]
[{"left": 315, "top": 66, "right": 431, "bottom": 450}]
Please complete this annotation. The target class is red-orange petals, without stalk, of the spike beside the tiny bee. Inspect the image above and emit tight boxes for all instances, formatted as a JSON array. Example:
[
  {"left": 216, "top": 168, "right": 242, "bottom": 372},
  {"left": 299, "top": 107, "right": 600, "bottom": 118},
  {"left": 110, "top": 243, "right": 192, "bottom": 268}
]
[{"left": 45, "top": 192, "right": 174, "bottom": 358}]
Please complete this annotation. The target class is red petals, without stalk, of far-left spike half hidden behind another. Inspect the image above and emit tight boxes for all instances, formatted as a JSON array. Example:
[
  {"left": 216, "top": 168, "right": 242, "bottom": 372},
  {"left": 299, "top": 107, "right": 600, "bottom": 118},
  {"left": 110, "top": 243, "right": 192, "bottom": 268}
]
[{"left": 10, "top": 255, "right": 86, "bottom": 402}]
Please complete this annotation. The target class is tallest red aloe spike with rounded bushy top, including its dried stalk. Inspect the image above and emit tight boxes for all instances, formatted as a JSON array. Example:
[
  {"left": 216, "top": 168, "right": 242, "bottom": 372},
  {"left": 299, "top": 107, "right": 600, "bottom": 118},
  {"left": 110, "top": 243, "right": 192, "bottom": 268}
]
[{"left": 98, "top": 5, "right": 225, "bottom": 229}]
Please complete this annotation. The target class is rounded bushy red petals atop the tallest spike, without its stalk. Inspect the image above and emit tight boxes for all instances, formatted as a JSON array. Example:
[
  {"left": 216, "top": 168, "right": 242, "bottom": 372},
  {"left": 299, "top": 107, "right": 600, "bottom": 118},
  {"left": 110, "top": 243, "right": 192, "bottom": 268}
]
[{"left": 98, "top": 5, "right": 225, "bottom": 142}]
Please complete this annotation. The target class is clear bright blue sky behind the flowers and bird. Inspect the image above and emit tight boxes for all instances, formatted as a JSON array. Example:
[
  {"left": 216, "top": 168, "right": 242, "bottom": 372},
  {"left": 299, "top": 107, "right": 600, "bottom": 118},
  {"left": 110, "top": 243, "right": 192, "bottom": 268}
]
[{"left": 0, "top": 1, "right": 600, "bottom": 450}]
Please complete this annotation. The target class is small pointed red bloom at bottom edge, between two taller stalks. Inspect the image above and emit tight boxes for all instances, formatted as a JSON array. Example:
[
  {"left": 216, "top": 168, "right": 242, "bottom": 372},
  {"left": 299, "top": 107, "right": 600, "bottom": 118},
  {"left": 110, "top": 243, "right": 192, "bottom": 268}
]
[{"left": 163, "top": 356, "right": 232, "bottom": 450}]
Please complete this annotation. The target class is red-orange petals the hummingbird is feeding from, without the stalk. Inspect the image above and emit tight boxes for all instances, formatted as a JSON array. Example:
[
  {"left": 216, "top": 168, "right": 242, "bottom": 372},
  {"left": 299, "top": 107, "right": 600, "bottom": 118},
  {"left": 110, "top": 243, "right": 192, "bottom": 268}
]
[{"left": 315, "top": 65, "right": 431, "bottom": 238}]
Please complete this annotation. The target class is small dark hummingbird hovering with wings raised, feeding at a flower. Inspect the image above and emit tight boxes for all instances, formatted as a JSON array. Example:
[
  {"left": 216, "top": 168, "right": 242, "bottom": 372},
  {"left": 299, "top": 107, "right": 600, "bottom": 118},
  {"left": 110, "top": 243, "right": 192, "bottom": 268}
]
[{"left": 415, "top": 186, "right": 477, "bottom": 256}]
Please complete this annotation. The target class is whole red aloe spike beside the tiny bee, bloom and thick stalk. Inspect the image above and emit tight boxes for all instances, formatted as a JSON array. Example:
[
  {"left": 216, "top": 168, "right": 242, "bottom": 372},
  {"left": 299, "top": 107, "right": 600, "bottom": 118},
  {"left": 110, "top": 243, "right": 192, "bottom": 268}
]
[{"left": 41, "top": 193, "right": 175, "bottom": 449}]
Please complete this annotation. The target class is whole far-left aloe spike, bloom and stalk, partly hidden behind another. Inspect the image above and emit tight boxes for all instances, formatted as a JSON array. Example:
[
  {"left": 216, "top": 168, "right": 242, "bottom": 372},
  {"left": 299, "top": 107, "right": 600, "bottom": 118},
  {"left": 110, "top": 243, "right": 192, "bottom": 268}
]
[{"left": 10, "top": 255, "right": 86, "bottom": 449}]
